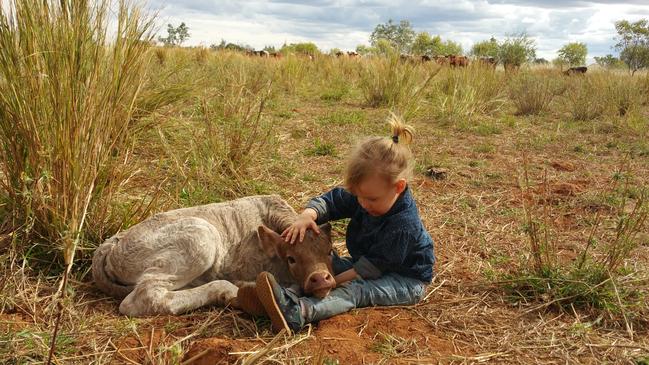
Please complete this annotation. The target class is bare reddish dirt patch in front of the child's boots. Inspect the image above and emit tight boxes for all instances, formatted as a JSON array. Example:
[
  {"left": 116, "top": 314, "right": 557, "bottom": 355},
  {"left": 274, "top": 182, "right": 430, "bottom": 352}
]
[{"left": 184, "top": 308, "right": 466, "bottom": 364}]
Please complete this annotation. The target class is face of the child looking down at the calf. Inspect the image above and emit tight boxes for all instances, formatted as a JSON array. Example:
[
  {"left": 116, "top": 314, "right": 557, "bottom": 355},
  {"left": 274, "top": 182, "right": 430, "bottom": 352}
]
[{"left": 355, "top": 175, "right": 406, "bottom": 217}]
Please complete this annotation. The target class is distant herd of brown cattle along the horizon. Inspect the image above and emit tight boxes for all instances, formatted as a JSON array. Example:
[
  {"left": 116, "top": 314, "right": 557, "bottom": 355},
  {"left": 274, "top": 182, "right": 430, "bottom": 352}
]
[{"left": 246, "top": 50, "right": 588, "bottom": 76}]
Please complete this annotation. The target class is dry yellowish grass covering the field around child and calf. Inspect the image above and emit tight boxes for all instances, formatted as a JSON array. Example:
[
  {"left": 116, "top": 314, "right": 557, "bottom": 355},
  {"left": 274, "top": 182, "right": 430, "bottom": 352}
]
[{"left": 0, "top": 8, "right": 649, "bottom": 364}]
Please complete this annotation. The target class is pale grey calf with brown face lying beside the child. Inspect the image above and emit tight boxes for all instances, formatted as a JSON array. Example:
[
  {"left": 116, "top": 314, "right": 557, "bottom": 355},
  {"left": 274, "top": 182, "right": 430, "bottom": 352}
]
[{"left": 92, "top": 195, "right": 335, "bottom": 316}]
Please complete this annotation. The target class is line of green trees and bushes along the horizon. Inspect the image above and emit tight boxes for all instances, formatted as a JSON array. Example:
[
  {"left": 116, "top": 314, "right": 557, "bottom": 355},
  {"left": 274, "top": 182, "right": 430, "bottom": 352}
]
[{"left": 158, "top": 19, "right": 649, "bottom": 74}]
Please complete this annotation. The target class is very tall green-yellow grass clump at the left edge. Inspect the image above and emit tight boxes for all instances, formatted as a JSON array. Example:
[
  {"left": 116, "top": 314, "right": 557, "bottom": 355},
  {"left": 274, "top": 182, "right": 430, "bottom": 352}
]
[{"left": 0, "top": 0, "right": 158, "bottom": 271}]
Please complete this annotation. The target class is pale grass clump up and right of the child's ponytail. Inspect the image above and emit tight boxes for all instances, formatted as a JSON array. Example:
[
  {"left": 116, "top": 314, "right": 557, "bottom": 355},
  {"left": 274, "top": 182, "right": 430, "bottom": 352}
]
[{"left": 430, "top": 67, "right": 505, "bottom": 123}]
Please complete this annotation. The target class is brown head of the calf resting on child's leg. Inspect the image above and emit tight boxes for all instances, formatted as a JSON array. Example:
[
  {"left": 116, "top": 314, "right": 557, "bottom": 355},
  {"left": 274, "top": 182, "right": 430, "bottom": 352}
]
[{"left": 257, "top": 223, "right": 336, "bottom": 298}]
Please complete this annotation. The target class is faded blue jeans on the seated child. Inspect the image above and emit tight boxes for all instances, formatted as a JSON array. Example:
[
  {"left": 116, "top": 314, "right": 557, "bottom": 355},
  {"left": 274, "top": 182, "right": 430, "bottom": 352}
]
[{"left": 298, "top": 253, "right": 426, "bottom": 324}]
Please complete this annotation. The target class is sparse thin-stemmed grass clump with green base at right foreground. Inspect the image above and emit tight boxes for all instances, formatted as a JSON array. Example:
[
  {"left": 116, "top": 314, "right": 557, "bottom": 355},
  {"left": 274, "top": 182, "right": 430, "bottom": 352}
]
[{"left": 502, "top": 162, "right": 649, "bottom": 328}]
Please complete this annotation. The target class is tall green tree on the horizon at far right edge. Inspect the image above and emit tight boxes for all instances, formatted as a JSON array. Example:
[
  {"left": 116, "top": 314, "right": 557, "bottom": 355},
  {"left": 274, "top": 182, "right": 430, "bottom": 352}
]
[{"left": 615, "top": 19, "right": 649, "bottom": 75}]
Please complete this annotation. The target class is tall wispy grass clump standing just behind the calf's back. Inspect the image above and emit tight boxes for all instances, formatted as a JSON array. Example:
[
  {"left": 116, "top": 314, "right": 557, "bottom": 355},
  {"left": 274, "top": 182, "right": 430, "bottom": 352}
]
[{"left": 181, "top": 55, "right": 276, "bottom": 200}]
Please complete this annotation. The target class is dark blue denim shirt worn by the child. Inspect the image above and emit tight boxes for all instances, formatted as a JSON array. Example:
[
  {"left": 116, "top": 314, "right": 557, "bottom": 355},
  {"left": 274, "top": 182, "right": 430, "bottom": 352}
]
[{"left": 307, "top": 187, "right": 435, "bottom": 283}]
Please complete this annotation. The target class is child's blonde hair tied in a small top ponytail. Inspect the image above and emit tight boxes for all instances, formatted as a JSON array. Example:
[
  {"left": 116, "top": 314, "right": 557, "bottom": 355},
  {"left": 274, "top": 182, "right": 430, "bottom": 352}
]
[{"left": 345, "top": 113, "right": 415, "bottom": 193}]
